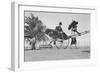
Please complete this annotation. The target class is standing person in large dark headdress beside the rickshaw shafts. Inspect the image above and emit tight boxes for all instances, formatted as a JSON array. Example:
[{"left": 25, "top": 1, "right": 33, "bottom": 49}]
[{"left": 68, "top": 20, "right": 80, "bottom": 49}]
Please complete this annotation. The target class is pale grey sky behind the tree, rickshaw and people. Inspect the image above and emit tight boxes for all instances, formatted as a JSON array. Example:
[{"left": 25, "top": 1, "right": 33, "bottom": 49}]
[{"left": 25, "top": 11, "right": 90, "bottom": 46}]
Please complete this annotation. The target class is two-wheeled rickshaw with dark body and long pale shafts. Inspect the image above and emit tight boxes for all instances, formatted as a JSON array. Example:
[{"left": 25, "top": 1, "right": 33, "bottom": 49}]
[{"left": 35, "top": 29, "right": 89, "bottom": 49}]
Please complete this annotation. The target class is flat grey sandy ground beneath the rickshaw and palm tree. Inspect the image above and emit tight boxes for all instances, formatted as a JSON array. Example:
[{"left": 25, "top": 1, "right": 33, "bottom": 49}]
[{"left": 24, "top": 47, "right": 90, "bottom": 62}]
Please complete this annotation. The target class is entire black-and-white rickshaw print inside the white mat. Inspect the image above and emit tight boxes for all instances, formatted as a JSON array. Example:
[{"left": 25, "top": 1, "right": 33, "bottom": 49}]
[{"left": 23, "top": 10, "right": 91, "bottom": 62}]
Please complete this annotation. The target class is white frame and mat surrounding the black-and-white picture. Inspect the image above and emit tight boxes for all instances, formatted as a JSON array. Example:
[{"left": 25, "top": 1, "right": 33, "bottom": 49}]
[{"left": 11, "top": 2, "right": 96, "bottom": 71}]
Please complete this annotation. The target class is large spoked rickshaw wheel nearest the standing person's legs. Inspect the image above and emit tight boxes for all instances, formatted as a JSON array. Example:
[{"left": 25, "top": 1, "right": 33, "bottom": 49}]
[{"left": 55, "top": 39, "right": 69, "bottom": 49}]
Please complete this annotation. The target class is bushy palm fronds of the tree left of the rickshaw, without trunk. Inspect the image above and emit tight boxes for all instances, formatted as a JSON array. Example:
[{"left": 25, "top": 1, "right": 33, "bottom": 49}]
[{"left": 24, "top": 13, "right": 47, "bottom": 41}]
